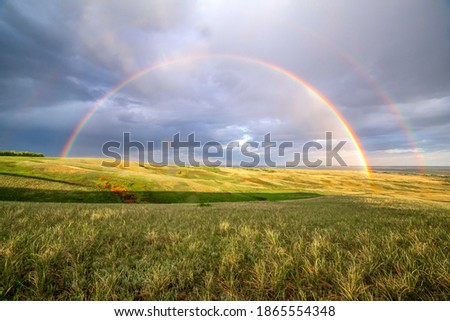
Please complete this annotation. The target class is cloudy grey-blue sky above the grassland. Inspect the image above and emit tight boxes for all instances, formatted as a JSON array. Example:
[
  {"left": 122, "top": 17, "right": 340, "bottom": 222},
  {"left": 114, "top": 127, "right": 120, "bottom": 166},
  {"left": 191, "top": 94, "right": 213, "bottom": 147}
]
[{"left": 0, "top": 0, "right": 450, "bottom": 166}]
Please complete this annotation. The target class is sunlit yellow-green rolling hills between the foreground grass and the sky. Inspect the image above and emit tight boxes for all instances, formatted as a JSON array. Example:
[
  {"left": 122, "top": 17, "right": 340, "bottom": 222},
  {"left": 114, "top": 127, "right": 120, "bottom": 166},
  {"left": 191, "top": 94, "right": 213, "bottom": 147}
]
[{"left": 0, "top": 157, "right": 448, "bottom": 203}]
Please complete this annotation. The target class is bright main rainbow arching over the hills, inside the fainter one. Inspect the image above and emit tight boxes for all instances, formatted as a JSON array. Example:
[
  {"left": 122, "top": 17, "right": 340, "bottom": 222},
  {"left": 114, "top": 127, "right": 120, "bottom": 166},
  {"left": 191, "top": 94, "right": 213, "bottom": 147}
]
[{"left": 61, "top": 54, "right": 370, "bottom": 173}]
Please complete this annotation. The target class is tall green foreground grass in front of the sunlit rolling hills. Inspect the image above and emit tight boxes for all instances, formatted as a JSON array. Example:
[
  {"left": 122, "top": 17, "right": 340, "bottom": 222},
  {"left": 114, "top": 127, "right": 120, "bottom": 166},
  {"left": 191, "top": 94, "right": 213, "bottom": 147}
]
[{"left": 0, "top": 197, "right": 450, "bottom": 300}]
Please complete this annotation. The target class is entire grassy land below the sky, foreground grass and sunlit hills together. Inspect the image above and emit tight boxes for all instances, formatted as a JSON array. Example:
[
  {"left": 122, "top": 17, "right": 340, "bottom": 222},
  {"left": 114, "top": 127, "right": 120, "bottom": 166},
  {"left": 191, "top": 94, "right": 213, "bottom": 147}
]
[{"left": 0, "top": 157, "right": 450, "bottom": 300}]
